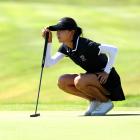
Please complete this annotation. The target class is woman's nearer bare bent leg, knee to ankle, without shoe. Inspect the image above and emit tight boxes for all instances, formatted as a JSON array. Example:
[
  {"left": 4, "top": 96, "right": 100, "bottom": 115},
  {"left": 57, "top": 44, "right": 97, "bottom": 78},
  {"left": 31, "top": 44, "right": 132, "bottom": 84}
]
[{"left": 74, "top": 74, "right": 108, "bottom": 102}]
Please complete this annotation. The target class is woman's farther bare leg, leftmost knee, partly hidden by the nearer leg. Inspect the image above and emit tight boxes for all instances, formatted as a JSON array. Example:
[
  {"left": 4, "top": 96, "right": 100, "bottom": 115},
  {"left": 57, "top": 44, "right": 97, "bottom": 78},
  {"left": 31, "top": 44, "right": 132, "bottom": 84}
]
[{"left": 58, "top": 74, "right": 94, "bottom": 101}]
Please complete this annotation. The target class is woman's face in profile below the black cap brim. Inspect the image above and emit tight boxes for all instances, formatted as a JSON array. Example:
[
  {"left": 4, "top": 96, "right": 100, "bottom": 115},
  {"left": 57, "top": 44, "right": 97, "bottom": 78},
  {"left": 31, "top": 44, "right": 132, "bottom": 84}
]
[{"left": 57, "top": 30, "right": 74, "bottom": 43}]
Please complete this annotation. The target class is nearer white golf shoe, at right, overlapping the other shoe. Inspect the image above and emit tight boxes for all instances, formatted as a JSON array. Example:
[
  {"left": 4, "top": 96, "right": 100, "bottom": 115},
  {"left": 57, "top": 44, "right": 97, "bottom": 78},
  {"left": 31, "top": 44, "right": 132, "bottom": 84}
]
[{"left": 91, "top": 100, "right": 114, "bottom": 116}]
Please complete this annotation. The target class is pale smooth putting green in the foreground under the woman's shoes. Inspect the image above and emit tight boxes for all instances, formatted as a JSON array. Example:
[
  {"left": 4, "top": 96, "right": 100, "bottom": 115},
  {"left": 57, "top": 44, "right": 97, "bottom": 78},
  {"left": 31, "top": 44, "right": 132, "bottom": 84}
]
[{"left": 0, "top": 111, "right": 140, "bottom": 140}]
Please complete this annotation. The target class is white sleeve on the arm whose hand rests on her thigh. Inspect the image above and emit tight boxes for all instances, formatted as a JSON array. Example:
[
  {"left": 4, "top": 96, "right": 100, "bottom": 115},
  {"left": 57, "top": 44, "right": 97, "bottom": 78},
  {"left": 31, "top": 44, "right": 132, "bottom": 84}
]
[{"left": 99, "top": 44, "right": 118, "bottom": 73}]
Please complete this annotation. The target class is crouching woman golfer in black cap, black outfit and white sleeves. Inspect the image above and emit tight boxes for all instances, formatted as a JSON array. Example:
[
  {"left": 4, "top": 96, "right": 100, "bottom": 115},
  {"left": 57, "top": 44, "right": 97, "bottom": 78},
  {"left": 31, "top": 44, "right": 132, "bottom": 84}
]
[{"left": 42, "top": 17, "right": 125, "bottom": 116}]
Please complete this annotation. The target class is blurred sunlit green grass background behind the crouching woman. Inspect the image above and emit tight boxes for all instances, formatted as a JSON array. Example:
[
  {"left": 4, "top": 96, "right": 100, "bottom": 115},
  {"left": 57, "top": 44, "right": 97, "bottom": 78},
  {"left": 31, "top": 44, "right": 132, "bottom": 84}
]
[{"left": 0, "top": 0, "right": 140, "bottom": 110}]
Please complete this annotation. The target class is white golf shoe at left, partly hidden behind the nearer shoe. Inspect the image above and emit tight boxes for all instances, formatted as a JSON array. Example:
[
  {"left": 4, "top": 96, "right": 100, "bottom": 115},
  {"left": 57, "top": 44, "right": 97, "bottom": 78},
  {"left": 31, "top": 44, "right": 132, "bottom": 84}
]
[{"left": 84, "top": 100, "right": 100, "bottom": 116}]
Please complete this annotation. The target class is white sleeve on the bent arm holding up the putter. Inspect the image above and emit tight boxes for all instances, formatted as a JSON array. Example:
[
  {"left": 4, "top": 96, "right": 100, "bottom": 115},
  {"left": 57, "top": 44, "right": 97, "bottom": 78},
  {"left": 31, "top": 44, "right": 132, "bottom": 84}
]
[{"left": 45, "top": 43, "right": 65, "bottom": 67}]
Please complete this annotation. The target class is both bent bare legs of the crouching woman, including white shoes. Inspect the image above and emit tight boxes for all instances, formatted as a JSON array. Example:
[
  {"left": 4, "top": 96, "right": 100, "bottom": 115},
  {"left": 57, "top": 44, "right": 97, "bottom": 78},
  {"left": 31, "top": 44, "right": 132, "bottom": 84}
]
[{"left": 58, "top": 74, "right": 113, "bottom": 116}]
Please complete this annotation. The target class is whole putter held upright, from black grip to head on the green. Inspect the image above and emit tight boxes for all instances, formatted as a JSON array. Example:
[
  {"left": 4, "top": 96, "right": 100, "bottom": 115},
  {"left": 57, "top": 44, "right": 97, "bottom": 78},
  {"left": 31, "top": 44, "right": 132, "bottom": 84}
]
[{"left": 30, "top": 33, "right": 49, "bottom": 117}]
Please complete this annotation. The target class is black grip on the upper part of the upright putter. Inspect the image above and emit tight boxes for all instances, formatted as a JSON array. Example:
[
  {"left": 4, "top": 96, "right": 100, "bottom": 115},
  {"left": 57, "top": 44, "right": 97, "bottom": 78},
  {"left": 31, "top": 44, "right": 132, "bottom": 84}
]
[{"left": 42, "top": 32, "right": 49, "bottom": 68}]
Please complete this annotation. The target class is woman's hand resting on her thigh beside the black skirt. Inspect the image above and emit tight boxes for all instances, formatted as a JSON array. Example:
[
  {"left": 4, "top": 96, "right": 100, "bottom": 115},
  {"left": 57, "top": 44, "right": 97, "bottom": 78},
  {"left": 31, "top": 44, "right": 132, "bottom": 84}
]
[{"left": 97, "top": 72, "right": 109, "bottom": 84}]
